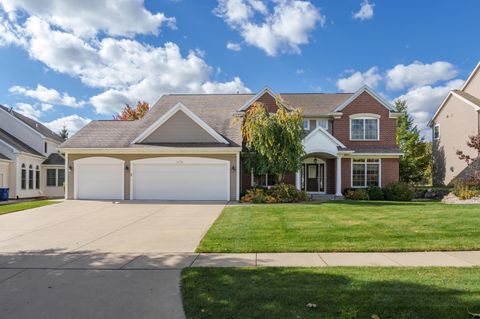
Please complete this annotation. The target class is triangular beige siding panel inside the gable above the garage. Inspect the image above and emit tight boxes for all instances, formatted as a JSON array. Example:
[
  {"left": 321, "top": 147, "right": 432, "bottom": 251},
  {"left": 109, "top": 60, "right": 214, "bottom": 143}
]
[{"left": 143, "top": 111, "right": 218, "bottom": 143}]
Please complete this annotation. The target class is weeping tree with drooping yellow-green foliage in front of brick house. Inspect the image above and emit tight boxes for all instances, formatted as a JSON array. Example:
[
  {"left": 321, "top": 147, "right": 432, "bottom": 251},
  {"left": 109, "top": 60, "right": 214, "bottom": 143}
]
[{"left": 241, "top": 98, "right": 305, "bottom": 182}]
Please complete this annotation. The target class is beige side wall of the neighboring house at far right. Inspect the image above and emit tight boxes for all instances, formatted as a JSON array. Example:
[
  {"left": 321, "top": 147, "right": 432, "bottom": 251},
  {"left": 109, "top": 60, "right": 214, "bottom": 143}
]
[{"left": 432, "top": 95, "right": 479, "bottom": 184}]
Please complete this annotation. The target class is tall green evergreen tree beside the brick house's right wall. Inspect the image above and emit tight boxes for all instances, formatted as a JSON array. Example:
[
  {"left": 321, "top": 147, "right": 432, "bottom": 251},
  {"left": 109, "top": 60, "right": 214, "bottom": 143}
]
[{"left": 395, "top": 100, "right": 432, "bottom": 184}]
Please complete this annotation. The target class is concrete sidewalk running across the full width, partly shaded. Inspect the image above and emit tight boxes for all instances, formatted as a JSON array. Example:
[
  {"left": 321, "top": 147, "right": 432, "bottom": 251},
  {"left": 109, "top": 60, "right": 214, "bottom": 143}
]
[{"left": 0, "top": 251, "right": 480, "bottom": 270}]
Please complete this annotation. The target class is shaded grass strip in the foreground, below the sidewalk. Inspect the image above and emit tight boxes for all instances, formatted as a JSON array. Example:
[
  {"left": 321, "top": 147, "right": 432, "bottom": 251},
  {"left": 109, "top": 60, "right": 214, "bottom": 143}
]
[{"left": 181, "top": 268, "right": 480, "bottom": 319}]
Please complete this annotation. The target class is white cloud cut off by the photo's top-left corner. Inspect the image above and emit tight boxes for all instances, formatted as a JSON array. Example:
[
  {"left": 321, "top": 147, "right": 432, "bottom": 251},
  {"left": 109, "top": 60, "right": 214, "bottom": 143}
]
[{"left": 0, "top": 0, "right": 175, "bottom": 37}]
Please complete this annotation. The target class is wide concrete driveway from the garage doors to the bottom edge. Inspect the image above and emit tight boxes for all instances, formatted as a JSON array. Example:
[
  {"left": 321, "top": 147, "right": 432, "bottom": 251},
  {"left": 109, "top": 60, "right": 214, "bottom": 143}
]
[{"left": 0, "top": 201, "right": 225, "bottom": 319}]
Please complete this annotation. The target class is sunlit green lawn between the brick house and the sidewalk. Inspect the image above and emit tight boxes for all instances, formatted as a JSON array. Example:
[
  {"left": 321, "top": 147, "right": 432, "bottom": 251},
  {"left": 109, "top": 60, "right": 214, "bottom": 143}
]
[{"left": 197, "top": 201, "right": 480, "bottom": 252}]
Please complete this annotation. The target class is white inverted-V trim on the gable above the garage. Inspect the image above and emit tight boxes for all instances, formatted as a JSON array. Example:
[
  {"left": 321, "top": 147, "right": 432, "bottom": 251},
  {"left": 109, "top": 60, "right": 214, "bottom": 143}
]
[{"left": 131, "top": 102, "right": 230, "bottom": 144}]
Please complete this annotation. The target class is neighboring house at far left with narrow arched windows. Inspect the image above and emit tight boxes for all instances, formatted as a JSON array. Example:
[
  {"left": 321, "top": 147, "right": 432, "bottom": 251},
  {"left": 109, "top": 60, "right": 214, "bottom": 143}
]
[{"left": 0, "top": 105, "right": 65, "bottom": 199}]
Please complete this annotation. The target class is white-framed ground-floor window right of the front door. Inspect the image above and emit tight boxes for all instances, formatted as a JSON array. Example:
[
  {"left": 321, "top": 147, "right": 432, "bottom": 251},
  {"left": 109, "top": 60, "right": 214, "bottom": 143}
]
[{"left": 352, "top": 158, "right": 380, "bottom": 187}]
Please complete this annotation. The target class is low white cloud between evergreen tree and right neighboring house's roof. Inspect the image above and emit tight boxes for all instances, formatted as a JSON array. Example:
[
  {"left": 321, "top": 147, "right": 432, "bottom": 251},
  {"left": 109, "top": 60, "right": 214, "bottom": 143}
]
[{"left": 395, "top": 79, "right": 464, "bottom": 135}]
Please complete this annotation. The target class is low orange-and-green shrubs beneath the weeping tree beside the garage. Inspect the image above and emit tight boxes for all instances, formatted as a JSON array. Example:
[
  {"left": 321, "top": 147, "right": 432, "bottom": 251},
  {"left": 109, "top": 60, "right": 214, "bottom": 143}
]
[{"left": 241, "top": 183, "right": 309, "bottom": 204}]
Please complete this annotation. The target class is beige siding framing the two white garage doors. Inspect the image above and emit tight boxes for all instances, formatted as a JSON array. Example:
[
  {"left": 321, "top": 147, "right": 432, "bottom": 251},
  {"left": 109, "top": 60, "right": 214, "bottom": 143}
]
[{"left": 67, "top": 153, "right": 238, "bottom": 200}]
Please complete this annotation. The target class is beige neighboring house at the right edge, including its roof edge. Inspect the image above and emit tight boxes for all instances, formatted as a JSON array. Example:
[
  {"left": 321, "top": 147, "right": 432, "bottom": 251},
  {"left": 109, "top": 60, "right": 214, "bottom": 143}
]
[{"left": 429, "top": 63, "right": 480, "bottom": 185}]
